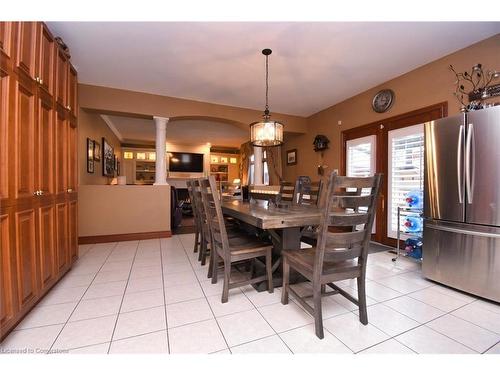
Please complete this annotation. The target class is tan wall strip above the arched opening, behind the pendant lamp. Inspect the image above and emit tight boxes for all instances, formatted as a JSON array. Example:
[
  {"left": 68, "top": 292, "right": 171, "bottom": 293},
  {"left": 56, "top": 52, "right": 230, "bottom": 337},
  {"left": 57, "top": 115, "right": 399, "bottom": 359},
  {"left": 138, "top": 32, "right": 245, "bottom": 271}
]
[{"left": 78, "top": 84, "right": 306, "bottom": 133}]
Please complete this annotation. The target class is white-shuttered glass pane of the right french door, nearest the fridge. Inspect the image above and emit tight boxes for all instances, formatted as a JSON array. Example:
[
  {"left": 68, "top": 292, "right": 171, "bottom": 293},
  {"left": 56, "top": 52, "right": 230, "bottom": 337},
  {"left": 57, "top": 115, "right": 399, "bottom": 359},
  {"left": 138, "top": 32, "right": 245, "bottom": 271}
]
[{"left": 387, "top": 124, "right": 424, "bottom": 239}]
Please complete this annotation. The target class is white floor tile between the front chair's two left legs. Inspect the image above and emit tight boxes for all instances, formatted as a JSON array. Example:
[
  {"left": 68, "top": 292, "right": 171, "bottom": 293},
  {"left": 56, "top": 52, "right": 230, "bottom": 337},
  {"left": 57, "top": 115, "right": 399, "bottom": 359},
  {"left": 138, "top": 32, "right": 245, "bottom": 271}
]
[{"left": 259, "top": 301, "right": 314, "bottom": 333}]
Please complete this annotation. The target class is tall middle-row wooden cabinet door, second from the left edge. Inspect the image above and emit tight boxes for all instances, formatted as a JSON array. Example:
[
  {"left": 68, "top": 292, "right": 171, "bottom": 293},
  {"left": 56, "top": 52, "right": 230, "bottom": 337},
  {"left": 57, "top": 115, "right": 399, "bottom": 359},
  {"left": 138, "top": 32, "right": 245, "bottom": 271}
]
[{"left": 11, "top": 81, "right": 35, "bottom": 198}]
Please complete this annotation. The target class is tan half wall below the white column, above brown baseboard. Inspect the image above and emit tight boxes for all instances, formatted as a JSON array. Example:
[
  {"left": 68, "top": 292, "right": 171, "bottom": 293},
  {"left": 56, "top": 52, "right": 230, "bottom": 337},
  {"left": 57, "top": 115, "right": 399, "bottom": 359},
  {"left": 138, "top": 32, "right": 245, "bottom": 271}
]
[{"left": 78, "top": 185, "right": 170, "bottom": 237}]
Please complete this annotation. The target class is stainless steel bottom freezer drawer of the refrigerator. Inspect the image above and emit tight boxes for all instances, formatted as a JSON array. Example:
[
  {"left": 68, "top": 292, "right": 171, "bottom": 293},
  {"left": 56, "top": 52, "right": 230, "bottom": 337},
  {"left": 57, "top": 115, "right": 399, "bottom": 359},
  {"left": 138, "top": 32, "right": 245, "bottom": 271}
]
[{"left": 422, "top": 220, "right": 500, "bottom": 302}]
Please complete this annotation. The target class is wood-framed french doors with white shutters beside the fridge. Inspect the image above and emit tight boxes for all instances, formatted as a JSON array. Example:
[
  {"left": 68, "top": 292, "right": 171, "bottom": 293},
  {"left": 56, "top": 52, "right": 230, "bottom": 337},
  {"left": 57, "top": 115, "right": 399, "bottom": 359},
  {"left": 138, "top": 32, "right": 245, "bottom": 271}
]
[{"left": 341, "top": 103, "right": 447, "bottom": 246}]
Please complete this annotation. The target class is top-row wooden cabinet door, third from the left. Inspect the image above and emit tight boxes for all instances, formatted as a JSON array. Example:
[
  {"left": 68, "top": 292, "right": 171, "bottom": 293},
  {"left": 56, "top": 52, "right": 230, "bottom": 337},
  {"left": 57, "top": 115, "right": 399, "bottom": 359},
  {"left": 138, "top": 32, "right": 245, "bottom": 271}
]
[{"left": 36, "top": 22, "right": 55, "bottom": 95}]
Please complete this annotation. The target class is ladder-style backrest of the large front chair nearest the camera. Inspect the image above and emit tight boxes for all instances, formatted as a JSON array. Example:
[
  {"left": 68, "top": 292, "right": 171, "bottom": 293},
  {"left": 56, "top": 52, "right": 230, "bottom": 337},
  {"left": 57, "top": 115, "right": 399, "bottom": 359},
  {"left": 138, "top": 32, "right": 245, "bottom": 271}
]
[{"left": 314, "top": 172, "right": 381, "bottom": 277}]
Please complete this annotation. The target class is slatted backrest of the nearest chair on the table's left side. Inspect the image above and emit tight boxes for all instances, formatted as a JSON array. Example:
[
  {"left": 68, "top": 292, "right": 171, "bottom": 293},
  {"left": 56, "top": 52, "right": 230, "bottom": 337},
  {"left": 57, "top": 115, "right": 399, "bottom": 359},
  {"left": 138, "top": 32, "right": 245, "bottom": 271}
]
[{"left": 198, "top": 176, "right": 231, "bottom": 263}]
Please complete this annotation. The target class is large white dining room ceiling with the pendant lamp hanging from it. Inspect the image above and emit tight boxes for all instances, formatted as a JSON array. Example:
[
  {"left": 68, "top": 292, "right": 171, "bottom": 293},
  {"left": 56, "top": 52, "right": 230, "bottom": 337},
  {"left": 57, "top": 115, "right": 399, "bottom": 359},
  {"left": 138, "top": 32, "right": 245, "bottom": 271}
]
[{"left": 48, "top": 22, "right": 500, "bottom": 116}]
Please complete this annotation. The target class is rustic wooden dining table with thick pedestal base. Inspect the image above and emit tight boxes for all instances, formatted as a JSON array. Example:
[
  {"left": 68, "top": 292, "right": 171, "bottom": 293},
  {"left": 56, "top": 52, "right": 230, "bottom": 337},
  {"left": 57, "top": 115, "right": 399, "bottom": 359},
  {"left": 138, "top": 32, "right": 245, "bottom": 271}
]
[{"left": 221, "top": 200, "right": 321, "bottom": 291}]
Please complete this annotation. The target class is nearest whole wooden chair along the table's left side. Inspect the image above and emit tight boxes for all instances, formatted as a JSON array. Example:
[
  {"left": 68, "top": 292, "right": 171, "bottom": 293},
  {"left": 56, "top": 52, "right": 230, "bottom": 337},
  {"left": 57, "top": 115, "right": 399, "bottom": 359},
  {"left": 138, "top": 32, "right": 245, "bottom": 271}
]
[{"left": 199, "top": 176, "right": 273, "bottom": 303}]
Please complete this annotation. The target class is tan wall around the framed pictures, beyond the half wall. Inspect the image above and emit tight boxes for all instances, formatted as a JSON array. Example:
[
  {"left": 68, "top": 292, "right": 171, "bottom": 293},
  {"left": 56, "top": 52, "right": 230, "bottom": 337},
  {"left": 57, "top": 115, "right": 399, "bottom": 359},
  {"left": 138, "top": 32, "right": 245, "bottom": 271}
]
[{"left": 78, "top": 109, "right": 121, "bottom": 185}]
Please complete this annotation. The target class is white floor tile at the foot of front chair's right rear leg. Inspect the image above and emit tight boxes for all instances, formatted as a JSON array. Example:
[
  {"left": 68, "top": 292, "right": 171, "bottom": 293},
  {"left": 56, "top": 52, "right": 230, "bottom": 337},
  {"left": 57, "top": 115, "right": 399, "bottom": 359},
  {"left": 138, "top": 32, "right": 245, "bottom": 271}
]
[{"left": 323, "top": 313, "right": 389, "bottom": 352}]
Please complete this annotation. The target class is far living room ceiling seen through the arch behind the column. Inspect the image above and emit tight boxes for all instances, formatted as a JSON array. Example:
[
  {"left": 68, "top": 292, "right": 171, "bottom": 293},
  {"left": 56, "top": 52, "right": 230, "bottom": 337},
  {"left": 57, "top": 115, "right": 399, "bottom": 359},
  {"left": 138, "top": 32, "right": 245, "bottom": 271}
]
[{"left": 102, "top": 115, "right": 249, "bottom": 148}]
